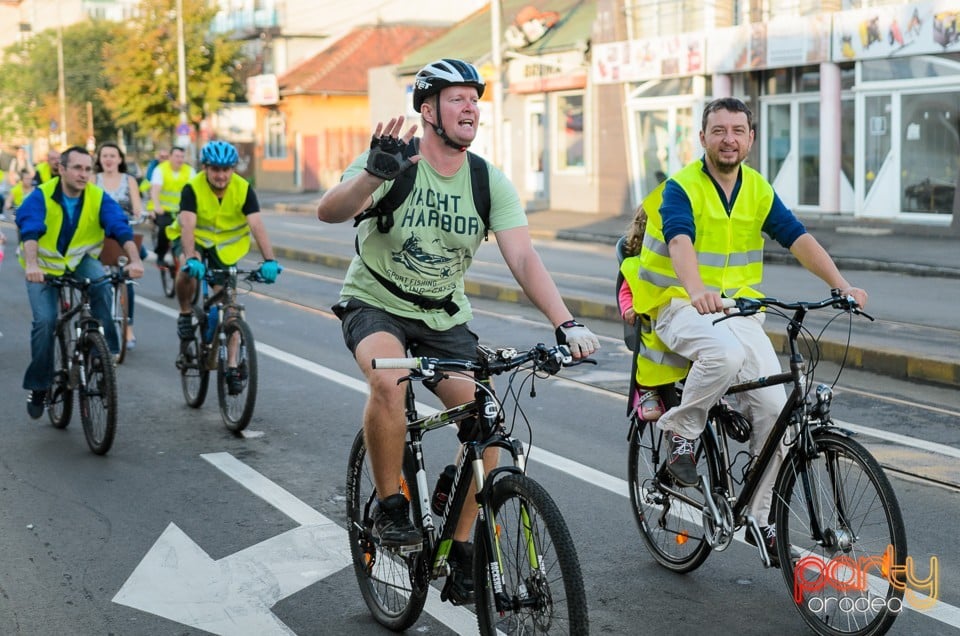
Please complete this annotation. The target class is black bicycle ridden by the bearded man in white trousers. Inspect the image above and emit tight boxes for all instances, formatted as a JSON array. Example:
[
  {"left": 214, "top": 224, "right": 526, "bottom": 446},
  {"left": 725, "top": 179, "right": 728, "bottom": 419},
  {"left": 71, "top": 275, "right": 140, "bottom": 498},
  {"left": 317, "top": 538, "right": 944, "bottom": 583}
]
[{"left": 628, "top": 290, "right": 907, "bottom": 636}]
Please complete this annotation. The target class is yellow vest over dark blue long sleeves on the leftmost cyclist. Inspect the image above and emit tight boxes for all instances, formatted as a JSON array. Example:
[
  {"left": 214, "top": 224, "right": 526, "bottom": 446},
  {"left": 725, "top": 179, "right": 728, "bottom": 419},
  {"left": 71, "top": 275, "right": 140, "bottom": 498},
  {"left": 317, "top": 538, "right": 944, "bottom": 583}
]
[{"left": 20, "top": 177, "right": 105, "bottom": 276}]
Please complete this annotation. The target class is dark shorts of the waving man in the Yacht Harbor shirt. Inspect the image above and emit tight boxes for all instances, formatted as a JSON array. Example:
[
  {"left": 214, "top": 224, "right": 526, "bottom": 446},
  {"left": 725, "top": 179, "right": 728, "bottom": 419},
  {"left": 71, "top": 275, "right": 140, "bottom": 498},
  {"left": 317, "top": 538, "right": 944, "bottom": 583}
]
[{"left": 333, "top": 298, "right": 480, "bottom": 360}]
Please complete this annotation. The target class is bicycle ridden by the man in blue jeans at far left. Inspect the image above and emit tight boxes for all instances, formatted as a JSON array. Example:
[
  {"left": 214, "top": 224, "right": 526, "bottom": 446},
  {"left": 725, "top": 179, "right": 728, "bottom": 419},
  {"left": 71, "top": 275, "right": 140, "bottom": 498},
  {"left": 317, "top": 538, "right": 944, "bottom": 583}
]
[{"left": 46, "top": 272, "right": 127, "bottom": 455}]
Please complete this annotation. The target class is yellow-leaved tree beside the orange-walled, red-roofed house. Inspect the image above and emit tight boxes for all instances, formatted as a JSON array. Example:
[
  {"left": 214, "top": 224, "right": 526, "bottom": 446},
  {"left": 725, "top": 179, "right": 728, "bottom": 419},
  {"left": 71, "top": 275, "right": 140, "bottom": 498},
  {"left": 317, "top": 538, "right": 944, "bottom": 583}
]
[{"left": 104, "top": 0, "right": 241, "bottom": 138}]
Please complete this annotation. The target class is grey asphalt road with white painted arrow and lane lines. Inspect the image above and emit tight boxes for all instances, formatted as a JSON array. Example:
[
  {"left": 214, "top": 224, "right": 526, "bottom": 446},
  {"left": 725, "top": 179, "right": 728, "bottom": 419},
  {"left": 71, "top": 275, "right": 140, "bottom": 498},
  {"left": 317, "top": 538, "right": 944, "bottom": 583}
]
[{"left": 0, "top": 230, "right": 960, "bottom": 635}]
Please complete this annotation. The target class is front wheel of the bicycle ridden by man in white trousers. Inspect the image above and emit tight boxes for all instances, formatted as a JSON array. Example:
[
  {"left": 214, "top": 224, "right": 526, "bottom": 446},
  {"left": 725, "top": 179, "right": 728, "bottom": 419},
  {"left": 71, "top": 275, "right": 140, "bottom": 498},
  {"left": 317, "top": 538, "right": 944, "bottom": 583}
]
[{"left": 774, "top": 431, "right": 907, "bottom": 636}]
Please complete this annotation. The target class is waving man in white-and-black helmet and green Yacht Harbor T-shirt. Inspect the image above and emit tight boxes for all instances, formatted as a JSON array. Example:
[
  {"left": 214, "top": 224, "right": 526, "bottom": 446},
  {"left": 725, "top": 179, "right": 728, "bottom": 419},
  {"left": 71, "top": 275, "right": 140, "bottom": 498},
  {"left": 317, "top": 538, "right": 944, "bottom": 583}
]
[{"left": 317, "top": 59, "right": 600, "bottom": 603}]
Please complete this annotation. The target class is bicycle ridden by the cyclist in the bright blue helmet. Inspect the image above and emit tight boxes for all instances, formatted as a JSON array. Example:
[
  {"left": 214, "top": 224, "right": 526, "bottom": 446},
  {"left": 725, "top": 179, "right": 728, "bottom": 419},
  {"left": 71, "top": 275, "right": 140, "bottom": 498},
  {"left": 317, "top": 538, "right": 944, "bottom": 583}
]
[{"left": 177, "top": 267, "right": 263, "bottom": 433}]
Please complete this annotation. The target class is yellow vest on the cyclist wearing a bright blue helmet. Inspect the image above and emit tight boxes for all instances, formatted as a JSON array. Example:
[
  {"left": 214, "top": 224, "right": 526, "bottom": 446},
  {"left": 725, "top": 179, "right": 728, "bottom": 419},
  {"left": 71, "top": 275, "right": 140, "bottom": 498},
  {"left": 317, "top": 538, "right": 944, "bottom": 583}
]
[{"left": 167, "top": 172, "right": 250, "bottom": 265}]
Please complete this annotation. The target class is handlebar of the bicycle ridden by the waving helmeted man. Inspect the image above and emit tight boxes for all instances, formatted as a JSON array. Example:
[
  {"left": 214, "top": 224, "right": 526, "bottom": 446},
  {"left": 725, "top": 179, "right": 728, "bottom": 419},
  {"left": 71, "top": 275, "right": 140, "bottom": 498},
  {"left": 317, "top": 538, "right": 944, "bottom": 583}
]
[{"left": 370, "top": 343, "right": 577, "bottom": 377}]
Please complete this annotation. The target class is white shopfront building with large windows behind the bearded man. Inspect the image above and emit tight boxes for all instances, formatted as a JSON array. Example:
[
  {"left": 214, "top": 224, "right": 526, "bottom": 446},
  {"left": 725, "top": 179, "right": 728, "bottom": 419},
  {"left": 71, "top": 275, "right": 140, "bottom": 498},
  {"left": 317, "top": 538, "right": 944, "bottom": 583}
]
[{"left": 591, "top": 0, "right": 960, "bottom": 225}]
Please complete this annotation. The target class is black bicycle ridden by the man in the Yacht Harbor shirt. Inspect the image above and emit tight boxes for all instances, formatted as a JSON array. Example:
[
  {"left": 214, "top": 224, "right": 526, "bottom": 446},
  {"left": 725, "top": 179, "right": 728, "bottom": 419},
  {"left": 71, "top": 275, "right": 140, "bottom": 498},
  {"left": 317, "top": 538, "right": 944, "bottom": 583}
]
[{"left": 347, "top": 344, "right": 589, "bottom": 634}]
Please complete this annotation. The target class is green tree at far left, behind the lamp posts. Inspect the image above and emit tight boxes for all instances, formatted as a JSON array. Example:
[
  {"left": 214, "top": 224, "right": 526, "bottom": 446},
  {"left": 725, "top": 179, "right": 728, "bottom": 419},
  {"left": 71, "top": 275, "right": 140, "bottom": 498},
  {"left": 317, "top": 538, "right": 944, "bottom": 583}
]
[{"left": 0, "top": 21, "right": 123, "bottom": 144}]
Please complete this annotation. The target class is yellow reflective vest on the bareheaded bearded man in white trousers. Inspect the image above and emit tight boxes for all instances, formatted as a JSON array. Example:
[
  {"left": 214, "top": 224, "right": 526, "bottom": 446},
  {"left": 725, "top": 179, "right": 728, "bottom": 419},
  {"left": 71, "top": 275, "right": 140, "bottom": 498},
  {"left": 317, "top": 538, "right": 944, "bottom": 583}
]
[{"left": 634, "top": 160, "right": 774, "bottom": 319}]
